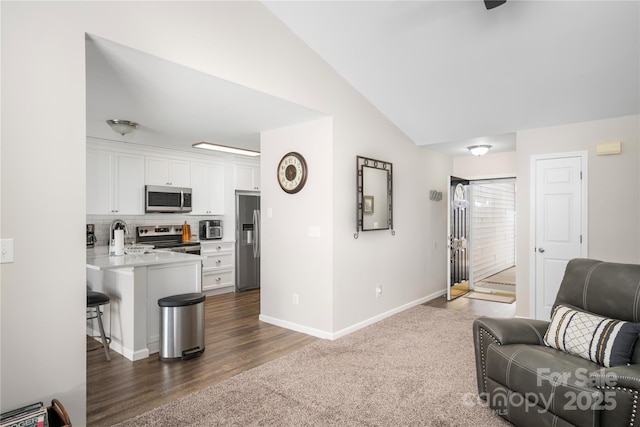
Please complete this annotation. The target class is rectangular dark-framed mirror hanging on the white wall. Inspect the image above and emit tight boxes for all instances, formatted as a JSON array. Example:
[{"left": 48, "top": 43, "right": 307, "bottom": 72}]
[{"left": 353, "top": 156, "right": 395, "bottom": 239}]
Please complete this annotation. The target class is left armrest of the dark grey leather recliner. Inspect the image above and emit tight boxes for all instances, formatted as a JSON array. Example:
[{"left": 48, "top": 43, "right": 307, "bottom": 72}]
[{"left": 473, "top": 317, "right": 549, "bottom": 398}]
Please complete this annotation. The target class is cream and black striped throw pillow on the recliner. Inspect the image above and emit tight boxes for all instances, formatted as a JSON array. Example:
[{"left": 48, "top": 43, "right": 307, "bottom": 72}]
[{"left": 544, "top": 305, "right": 640, "bottom": 367}]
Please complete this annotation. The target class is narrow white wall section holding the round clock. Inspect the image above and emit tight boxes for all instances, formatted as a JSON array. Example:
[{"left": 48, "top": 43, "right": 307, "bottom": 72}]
[{"left": 260, "top": 118, "right": 334, "bottom": 336}]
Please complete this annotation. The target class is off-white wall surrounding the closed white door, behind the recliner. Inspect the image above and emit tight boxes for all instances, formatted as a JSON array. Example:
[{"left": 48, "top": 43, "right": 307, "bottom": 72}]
[{"left": 516, "top": 115, "right": 640, "bottom": 316}]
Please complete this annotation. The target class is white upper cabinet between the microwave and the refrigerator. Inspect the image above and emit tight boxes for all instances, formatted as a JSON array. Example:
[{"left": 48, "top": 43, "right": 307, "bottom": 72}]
[{"left": 191, "top": 162, "right": 225, "bottom": 215}]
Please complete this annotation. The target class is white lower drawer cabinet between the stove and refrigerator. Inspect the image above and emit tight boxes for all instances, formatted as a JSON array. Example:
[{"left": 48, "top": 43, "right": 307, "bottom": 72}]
[{"left": 200, "top": 240, "right": 235, "bottom": 295}]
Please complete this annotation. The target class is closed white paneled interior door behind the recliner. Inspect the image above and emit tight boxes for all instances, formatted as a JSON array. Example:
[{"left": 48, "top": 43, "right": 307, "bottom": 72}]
[{"left": 532, "top": 154, "right": 586, "bottom": 320}]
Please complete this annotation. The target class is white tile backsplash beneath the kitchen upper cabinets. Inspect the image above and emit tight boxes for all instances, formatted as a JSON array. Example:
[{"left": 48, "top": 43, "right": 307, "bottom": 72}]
[{"left": 87, "top": 214, "right": 235, "bottom": 246}]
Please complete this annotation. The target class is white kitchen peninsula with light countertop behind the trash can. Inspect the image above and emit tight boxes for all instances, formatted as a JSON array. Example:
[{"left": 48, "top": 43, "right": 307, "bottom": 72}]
[{"left": 87, "top": 246, "right": 203, "bottom": 361}]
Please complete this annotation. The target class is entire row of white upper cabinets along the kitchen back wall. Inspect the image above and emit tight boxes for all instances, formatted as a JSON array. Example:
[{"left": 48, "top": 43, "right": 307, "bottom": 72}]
[{"left": 87, "top": 138, "right": 260, "bottom": 215}]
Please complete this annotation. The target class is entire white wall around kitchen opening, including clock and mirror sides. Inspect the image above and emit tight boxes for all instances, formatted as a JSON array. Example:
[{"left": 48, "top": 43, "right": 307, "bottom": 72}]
[{"left": 0, "top": 2, "right": 451, "bottom": 425}]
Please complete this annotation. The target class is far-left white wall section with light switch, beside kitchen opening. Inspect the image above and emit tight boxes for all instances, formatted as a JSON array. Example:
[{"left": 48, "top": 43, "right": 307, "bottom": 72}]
[{"left": 0, "top": 2, "right": 86, "bottom": 425}]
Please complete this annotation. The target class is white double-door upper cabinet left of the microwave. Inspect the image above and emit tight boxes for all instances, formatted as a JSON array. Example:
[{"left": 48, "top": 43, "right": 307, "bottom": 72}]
[{"left": 87, "top": 148, "right": 144, "bottom": 215}]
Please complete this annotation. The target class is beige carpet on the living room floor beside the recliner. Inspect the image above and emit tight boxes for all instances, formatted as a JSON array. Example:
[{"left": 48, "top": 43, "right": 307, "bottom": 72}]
[{"left": 112, "top": 306, "right": 510, "bottom": 427}]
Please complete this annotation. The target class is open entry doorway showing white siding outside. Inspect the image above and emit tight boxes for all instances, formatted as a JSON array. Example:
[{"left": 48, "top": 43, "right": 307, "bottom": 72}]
[{"left": 447, "top": 177, "right": 516, "bottom": 302}]
